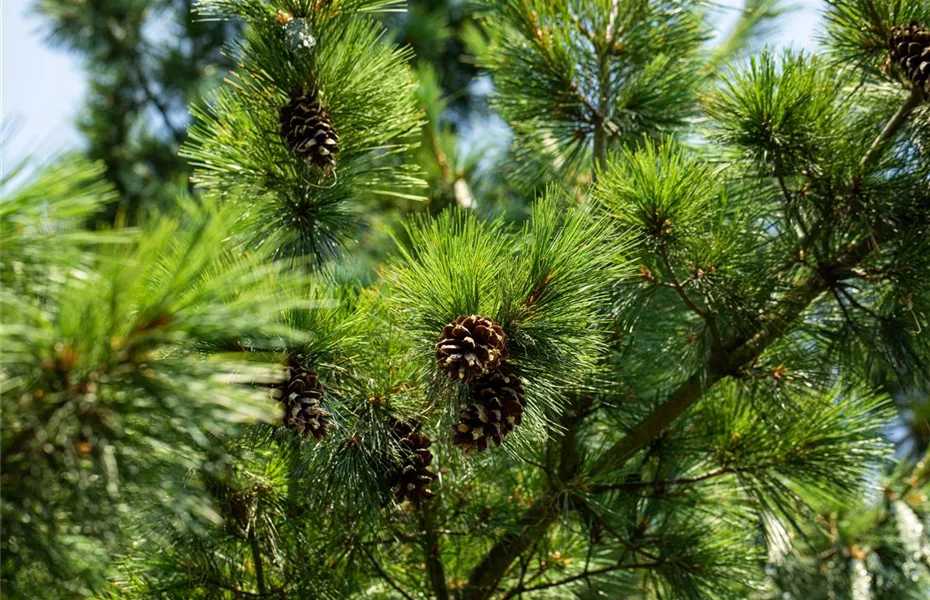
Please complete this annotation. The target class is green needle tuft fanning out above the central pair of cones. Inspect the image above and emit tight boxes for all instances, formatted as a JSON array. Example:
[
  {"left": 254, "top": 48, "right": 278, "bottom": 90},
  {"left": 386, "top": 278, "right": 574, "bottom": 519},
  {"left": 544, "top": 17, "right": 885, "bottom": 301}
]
[{"left": 389, "top": 190, "right": 629, "bottom": 408}]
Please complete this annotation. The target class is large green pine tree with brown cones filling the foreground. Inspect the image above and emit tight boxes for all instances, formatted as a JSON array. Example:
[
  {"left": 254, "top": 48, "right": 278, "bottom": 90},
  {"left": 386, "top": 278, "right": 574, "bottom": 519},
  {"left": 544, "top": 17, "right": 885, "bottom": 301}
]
[{"left": 0, "top": 0, "right": 930, "bottom": 600}]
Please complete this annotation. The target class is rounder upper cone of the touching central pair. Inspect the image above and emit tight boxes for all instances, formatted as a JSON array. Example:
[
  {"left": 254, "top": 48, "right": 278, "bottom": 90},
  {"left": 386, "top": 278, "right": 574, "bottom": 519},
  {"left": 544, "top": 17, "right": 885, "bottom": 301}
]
[{"left": 436, "top": 315, "right": 507, "bottom": 382}]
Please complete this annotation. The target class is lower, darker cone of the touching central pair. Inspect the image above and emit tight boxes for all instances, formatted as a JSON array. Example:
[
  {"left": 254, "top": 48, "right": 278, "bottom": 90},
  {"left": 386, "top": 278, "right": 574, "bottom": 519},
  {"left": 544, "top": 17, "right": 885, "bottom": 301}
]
[{"left": 452, "top": 365, "right": 526, "bottom": 453}]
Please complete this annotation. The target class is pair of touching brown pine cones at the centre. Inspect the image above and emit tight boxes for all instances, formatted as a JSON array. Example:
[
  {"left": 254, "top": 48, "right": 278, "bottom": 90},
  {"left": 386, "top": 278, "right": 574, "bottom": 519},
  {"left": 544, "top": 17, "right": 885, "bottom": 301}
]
[{"left": 436, "top": 315, "right": 526, "bottom": 453}]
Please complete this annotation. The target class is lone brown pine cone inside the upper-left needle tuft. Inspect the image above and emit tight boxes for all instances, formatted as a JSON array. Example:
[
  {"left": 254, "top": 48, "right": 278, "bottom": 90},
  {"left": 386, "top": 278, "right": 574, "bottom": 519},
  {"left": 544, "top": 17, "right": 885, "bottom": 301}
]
[{"left": 278, "top": 86, "right": 339, "bottom": 173}]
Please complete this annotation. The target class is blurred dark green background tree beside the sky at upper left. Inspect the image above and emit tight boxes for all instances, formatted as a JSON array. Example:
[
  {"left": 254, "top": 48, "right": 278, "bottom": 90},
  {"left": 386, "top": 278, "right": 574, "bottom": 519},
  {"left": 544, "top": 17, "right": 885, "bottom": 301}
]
[{"left": 35, "top": 0, "right": 240, "bottom": 222}]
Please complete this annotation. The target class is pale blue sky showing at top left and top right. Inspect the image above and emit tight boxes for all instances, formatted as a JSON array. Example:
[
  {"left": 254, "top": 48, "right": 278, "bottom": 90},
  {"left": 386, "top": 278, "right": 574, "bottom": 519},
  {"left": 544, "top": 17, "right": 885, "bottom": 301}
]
[{"left": 0, "top": 0, "right": 823, "bottom": 170}]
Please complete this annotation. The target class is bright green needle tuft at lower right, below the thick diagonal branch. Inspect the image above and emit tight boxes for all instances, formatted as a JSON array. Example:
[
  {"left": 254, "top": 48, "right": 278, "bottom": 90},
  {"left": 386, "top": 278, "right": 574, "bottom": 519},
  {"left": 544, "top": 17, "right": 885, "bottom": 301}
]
[{"left": 693, "top": 385, "right": 891, "bottom": 504}]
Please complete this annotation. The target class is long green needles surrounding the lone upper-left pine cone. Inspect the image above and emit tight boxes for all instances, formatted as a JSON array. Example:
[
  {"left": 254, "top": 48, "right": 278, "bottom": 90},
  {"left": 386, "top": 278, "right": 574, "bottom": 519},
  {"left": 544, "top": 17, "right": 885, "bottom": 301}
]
[{"left": 183, "top": 2, "right": 419, "bottom": 261}]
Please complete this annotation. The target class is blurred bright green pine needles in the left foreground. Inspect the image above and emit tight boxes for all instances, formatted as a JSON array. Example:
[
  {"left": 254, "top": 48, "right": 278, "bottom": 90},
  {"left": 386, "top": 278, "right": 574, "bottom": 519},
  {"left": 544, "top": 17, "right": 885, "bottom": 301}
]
[{"left": 0, "top": 161, "right": 312, "bottom": 597}]
